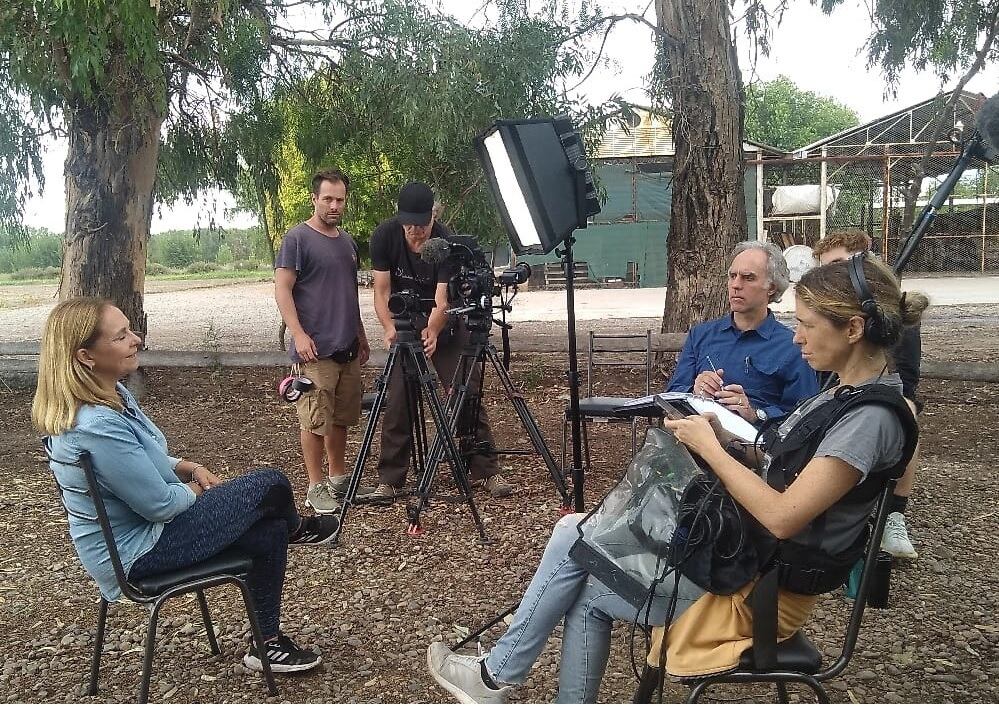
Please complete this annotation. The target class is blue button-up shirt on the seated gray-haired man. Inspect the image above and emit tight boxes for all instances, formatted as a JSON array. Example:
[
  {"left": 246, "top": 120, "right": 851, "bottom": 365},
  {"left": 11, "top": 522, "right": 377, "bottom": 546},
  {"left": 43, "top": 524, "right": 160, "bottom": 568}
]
[{"left": 666, "top": 312, "right": 819, "bottom": 418}]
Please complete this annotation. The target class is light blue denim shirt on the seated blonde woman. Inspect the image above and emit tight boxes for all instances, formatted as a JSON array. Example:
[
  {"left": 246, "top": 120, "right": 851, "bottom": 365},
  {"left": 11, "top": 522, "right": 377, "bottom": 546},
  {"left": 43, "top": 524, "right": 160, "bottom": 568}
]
[{"left": 49, "top": 383, "right": 197, "bottom": 600}]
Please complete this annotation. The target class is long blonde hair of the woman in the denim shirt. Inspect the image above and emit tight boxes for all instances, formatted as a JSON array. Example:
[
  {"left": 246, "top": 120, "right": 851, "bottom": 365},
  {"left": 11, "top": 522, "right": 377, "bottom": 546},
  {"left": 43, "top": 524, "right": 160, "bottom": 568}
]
[{"left": 31, "top": 297, "right": 122, "bottom": 435}]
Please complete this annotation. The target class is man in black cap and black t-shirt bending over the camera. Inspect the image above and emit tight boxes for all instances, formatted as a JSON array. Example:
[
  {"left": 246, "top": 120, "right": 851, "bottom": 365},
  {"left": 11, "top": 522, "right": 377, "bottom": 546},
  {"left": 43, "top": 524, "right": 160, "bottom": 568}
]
[{"left": 370, "top": 181, "right": 513, "bottom": 504}]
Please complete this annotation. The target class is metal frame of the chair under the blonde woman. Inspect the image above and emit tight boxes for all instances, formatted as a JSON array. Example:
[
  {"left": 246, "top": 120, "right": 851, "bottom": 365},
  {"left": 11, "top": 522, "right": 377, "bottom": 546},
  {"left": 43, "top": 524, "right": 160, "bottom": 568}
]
[{"left": 46, "top": 446, "right": 278, "bottom": 703}]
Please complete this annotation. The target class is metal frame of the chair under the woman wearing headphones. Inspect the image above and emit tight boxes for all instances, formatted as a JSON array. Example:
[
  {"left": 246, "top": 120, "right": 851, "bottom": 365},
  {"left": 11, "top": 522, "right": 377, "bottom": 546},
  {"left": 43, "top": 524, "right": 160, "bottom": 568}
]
[{"left": 634, "top": 480, "right": 895, "bottom": 703}]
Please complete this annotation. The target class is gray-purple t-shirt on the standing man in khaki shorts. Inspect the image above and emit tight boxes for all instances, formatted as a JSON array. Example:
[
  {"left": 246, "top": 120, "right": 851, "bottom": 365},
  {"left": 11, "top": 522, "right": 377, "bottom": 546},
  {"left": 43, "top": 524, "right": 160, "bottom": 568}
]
[{"left": 274, "top": 223, "right": 359, "bottom": 363}]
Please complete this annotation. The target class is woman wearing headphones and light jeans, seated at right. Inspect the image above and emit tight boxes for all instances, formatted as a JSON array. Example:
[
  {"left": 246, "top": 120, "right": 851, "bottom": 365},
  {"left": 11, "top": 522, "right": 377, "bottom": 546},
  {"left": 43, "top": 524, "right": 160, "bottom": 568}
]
[{"left": 427, "top": 257, "right": 927, "bottom": 703}]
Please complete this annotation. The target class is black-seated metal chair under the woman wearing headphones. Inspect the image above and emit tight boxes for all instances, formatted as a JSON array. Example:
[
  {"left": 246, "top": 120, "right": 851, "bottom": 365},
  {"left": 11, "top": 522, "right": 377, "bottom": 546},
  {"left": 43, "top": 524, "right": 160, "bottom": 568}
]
[{"left": 634, "top": 481, "right": 895, "bottom": 704}]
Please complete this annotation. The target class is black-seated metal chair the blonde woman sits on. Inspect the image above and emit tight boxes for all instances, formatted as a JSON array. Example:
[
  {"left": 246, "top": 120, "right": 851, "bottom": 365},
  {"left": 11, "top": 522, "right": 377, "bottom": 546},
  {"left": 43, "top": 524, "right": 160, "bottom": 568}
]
[{"left": 45, "top": 442, "right": 278, "bottom": 703}]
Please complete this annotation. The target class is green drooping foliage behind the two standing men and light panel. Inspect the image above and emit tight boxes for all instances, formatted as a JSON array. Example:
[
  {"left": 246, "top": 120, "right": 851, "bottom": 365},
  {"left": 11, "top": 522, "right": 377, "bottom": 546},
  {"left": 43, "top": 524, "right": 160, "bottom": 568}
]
[{"left": 232, "top": 0, "right": 619, "bottom": 254}]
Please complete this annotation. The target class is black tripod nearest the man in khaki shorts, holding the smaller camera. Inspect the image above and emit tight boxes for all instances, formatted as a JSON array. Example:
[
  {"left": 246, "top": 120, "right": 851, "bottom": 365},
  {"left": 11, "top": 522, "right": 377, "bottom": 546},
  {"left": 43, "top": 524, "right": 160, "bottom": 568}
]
[{"left": 337, "top": 314, "right": 487, "bottom": 542}]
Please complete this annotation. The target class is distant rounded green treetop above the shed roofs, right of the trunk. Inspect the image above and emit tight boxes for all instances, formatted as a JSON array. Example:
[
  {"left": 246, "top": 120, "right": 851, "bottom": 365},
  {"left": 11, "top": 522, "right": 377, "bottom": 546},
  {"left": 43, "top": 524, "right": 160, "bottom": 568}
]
[{"left": 745, "top": 76, "right": 860, "bottom": 151}]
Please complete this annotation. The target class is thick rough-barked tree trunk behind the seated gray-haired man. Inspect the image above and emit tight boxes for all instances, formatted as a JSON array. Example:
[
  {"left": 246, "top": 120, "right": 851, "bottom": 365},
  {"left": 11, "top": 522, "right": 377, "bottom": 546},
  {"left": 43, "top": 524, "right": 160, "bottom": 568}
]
[{"left": 656, "top": 0, "right": 746, "bottom": 332}]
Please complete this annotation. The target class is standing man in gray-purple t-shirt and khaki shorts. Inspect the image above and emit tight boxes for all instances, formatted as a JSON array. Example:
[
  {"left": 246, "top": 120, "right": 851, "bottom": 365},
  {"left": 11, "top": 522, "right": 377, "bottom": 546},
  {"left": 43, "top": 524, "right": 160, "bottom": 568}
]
[{"left": 274, "top": 169, "right": 374, "bottom": 514}]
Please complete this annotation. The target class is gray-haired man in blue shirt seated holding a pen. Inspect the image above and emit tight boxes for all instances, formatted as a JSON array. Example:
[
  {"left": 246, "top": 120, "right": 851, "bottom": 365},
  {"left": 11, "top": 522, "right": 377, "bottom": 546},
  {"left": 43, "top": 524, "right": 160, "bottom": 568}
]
[{"left": 667, "top": 240, "right": 819, "bottom": 424}]
